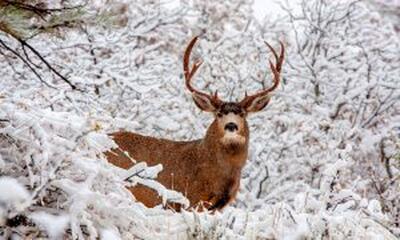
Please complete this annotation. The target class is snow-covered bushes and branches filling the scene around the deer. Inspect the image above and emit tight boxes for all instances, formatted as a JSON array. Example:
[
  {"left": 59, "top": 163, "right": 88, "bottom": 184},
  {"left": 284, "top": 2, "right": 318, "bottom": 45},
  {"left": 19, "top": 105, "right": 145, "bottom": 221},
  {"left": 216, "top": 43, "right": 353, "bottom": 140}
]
[{"left": 0, "top": 0, "right": 400, "bottom": 240}]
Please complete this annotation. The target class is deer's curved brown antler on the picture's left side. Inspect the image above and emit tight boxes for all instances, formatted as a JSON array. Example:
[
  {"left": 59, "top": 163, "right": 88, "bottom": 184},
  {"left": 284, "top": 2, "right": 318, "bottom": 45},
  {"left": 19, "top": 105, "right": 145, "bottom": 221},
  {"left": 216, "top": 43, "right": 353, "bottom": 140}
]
[{"left": 183, "top": 36, "right": 221, "bottom": 106}]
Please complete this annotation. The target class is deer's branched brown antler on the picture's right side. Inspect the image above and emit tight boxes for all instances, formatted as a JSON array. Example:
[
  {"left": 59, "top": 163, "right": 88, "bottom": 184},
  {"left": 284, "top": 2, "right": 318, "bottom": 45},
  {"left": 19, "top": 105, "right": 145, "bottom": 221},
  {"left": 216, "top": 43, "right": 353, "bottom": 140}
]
[{"left": 240, "top": 41, "right": 285, "bottom": 106}]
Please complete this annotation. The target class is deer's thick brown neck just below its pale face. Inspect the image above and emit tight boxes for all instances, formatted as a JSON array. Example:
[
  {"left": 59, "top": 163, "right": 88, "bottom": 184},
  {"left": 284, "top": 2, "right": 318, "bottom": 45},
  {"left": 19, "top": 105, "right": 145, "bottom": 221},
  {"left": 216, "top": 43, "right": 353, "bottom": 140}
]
[{"left": 202, "top": 121, "right": 249, "bottom": 169}]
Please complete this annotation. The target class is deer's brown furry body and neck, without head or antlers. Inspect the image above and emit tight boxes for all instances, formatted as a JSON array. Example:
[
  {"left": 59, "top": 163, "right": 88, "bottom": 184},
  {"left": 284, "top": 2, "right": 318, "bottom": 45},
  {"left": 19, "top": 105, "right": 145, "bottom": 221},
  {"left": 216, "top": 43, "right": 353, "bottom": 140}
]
[{"left": 106, "top": 119, "right": 249, "bottom": 210}]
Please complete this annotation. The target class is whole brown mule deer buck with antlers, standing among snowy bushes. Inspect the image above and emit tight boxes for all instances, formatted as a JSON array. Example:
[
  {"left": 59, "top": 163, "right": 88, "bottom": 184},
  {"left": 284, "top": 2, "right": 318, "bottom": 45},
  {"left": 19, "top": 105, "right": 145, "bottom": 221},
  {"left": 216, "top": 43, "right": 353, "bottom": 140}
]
[{"left": 106, "top": 37, "right": 284, "bottom": 211}]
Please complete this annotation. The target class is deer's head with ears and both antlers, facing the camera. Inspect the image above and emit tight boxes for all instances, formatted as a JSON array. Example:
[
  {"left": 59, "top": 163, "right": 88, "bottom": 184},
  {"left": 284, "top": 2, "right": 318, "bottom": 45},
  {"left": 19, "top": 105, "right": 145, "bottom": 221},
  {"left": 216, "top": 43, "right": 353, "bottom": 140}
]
[{"left": 183, "top": 36, "right": 285, "bottom": 150}]
